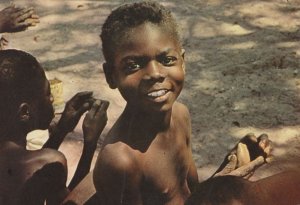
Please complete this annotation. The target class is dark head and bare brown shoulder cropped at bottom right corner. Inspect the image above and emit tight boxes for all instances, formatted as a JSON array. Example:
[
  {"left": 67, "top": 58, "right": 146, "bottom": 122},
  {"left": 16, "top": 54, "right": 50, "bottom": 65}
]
[{"left": 185, "top": 170, "right": 300, "bottom": 205}]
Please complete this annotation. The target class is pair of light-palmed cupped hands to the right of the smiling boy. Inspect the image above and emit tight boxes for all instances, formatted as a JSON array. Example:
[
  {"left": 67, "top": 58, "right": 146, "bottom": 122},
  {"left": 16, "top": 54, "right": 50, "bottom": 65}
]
[{"left": 214, "top": 133, "right": 272, "bottom": 178}]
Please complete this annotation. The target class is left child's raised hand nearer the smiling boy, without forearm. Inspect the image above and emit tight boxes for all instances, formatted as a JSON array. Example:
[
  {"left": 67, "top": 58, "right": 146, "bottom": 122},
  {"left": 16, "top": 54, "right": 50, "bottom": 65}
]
[{"left": 82, "top": 100, "right": 109, "bottom": 146}]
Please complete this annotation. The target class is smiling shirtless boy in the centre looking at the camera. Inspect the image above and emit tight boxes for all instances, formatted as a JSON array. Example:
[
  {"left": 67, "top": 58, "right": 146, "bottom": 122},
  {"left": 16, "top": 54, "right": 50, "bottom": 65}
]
[{"left": 93, "top": 2, "right": 270, "bottom": 205}]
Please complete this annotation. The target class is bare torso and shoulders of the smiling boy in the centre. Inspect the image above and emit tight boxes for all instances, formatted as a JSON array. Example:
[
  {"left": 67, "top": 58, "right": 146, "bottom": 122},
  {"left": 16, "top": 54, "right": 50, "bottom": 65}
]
[{"left": 94, "top": 103, "right": 197, "bottom": 205}]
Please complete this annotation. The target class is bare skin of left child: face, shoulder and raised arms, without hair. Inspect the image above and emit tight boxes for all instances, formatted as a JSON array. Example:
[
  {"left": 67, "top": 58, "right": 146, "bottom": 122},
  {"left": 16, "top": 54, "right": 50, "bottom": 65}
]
[{"left": 0, "top": 67, "right": 108, "bottom": 205}]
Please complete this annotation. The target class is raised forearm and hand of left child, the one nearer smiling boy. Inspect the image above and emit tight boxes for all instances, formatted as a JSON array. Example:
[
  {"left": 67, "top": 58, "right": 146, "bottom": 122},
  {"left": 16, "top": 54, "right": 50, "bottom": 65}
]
[{"left": 68, "top": 100, "right": 109, "bottom": 190}]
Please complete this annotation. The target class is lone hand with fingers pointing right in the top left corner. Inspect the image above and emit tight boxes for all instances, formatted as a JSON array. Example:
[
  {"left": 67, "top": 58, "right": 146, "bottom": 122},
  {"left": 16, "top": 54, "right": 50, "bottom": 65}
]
[{"left": 0, "top": 5, "right": 40, "bottom": 33}]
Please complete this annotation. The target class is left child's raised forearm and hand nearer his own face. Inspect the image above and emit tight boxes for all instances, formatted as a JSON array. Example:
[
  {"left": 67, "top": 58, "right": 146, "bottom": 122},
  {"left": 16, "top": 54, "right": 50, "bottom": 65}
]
[{"left": 43, "top": 92, "right": 94, "bottom": 149}]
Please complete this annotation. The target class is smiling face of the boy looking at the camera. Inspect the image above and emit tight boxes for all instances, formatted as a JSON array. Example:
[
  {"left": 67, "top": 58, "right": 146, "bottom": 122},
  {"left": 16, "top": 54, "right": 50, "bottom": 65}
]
[{"left": 106, "top": 23, "right": 184, "bottom": 112}]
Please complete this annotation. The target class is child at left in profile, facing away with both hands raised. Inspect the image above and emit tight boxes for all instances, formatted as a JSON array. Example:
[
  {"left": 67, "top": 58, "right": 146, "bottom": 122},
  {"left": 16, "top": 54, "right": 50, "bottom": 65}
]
[{"left": 0, "top": 50, "right": 108, "bottom": 205}]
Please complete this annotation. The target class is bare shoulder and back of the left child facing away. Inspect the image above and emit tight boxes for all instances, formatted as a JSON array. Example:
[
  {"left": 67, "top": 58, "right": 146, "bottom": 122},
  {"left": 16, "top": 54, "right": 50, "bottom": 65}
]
[{"left": 0, "top": 142, "right": 66, "bottom": 205}]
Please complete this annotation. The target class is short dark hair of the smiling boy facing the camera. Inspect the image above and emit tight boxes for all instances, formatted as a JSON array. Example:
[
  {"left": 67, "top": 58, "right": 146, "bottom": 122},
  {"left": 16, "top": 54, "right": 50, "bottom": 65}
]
[{"left": 100, "top": 1, "right": 181, "bottom": 62}]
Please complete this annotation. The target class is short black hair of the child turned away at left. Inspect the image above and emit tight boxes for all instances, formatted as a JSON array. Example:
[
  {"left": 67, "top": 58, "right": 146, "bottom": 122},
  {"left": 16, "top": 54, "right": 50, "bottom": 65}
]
[{"left": 0, "top": 49, "right": 45, "bottom": 123}]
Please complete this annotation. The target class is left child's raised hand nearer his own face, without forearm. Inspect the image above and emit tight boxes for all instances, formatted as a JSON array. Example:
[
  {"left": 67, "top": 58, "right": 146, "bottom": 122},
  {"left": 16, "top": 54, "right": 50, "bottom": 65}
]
[{"left": 57, "top": 91, "right": 95, "bottom": 132}]
